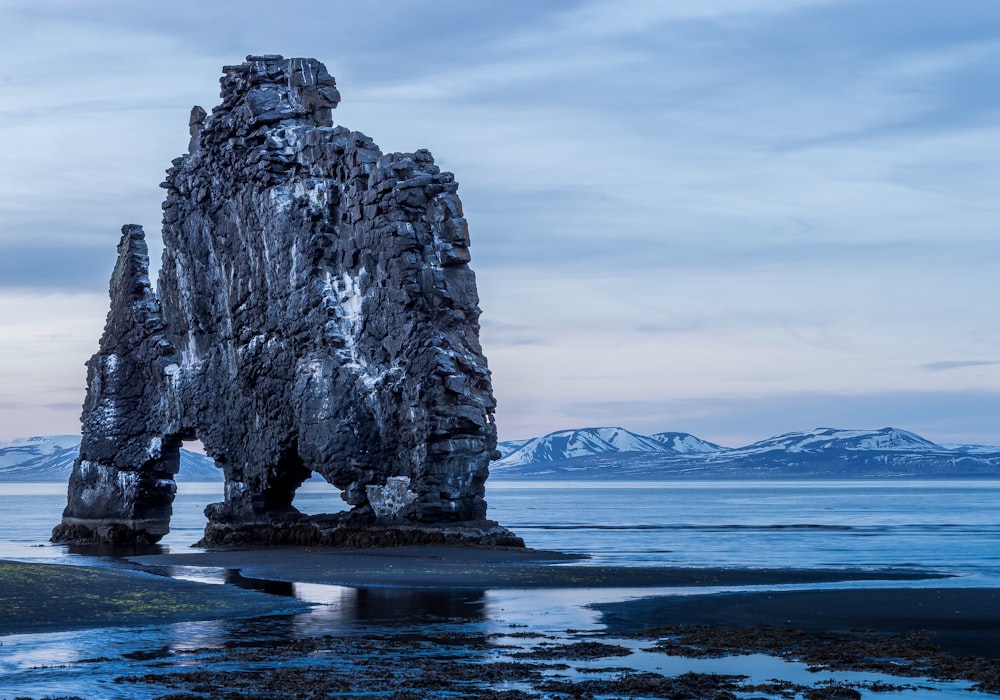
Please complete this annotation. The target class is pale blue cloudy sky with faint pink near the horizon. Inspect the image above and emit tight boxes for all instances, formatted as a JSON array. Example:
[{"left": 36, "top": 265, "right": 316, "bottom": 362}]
[{"left": 0, "top": 0, "right": 1000, "bottom": 447}]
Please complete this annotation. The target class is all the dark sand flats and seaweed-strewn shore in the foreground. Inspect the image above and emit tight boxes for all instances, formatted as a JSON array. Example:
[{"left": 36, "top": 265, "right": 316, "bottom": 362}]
[{"left": 0, "top": 546, "right": 1000, "bottom": 700}]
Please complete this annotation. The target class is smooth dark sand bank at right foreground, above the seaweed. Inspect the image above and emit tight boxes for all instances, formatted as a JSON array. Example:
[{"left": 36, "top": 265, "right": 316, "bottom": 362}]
[{"left": 593, "top": 588, "right": 1000, "bottom": 697}]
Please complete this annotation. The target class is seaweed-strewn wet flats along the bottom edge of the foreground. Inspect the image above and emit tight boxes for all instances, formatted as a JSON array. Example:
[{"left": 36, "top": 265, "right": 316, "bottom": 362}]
[{"left": 21, "top": 617, "right": 1000, "bottom": 700}]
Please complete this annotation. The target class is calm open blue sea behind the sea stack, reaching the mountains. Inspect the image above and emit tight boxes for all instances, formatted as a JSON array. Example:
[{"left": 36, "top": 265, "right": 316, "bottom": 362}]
[{"left": 0, "top": 480, "right": 1000, "bottom": 586}]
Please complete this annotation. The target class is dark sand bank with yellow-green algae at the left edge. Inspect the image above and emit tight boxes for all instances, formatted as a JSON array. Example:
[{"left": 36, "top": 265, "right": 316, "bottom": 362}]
[{"left": 0, "top": 561, "right": 308, "bottom": 635}]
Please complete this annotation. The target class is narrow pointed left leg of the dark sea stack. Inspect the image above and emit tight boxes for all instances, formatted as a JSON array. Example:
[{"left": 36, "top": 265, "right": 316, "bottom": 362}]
[{"left": 53, "top": 226, "right": 179, "bottom": 544}]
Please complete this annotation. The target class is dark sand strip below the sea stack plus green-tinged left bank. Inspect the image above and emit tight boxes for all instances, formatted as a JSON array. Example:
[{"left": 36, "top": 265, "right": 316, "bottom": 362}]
[{"left": 0, "top": 545, "right": 960, "bottom": 634}]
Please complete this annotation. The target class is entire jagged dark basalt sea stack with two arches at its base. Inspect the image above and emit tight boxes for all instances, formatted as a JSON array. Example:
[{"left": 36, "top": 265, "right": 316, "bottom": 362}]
[{"left": 53, "top": 55, "right": 523, "bottom": 546}]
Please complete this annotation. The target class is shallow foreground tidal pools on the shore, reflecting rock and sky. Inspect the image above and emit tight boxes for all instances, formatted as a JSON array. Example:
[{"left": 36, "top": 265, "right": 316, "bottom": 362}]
[{"left": 0, "top": 586, "right": 996, "bottom": 700}]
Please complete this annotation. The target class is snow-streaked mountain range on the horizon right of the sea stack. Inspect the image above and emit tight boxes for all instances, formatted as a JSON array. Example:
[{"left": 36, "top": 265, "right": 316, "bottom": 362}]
[{"left": 490, "top": 427, "right": 1000, "bottom": 480}]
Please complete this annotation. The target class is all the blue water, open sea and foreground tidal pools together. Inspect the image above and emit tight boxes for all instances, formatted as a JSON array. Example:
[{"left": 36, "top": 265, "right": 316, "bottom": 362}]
[{"left": 0, "top": 480, "right": 1000, "bottom": 699}]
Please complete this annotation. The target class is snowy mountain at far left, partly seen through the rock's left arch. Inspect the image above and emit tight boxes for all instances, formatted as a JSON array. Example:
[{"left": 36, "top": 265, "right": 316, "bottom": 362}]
[{"left": 0, "top": 435, "right": 223, "bottom": 481}]
